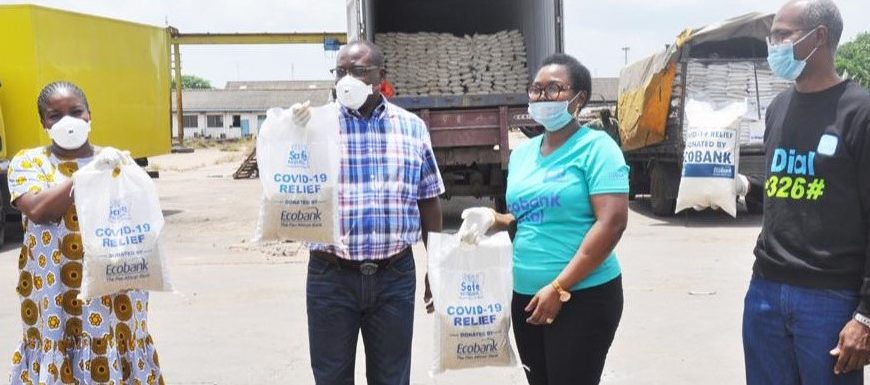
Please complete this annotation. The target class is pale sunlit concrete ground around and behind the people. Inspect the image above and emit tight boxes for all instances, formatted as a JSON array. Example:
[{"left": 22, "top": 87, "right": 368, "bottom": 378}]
[{"left": 0, "top": 146, "right": 864, "bottom": 385}]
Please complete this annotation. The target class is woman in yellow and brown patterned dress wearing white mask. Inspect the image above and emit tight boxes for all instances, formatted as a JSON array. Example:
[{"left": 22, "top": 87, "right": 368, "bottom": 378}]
[{"left": 8, "top": 82, "right": 163, "bottom": 385}]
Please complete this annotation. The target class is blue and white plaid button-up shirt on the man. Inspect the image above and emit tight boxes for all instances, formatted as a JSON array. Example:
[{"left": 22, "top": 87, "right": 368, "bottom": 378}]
[{"left": 309, "top": 99, "right": 444, "bottom": 260}]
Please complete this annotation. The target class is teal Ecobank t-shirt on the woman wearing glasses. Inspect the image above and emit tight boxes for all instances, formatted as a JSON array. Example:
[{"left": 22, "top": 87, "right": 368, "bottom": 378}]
[{"left": 506, "top": 127, "right": 628, "bottom": 295}]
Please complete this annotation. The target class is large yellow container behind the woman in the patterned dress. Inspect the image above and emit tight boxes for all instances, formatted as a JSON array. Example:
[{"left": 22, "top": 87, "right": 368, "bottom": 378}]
[{"left": 0, "top": 5, "right": 171, "bottom": 159}]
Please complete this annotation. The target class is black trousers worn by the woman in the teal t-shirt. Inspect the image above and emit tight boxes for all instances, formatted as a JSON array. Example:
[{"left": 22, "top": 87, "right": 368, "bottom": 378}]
[{"left": 511, "top": 277, "right": 623, "bottom": 385}]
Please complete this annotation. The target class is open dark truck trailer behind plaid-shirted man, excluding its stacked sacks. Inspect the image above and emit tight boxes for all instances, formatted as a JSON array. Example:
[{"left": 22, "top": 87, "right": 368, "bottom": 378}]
[{"left": 347, "top": 0, "right": 563, "bottom": 209}]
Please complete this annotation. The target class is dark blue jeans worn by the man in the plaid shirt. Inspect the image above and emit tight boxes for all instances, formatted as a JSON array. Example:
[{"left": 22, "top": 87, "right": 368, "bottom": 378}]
[{"left": 306, "top": 255, "right": 417, "bottom": 385}]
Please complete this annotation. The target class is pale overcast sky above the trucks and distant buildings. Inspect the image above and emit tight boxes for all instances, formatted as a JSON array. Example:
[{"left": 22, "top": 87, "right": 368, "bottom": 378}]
[{"left": 6, "top": 0, "right": 870, "bottom": 87}]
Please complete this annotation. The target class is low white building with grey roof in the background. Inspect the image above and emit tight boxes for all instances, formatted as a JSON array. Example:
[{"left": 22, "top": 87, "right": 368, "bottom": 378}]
[{"left": 172, "top": 80, "right": 334, "bottom": 139}]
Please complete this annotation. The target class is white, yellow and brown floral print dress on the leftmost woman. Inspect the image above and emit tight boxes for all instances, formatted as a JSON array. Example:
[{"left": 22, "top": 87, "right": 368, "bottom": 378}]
[{"left": 8, "top": 147, "right": 163, "bottom": 385}]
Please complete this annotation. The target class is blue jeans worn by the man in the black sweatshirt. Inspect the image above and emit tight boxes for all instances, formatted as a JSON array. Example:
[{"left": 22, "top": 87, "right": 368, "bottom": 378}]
[{"left": 743, "top": 277, "right": 864, "bottom": 385}]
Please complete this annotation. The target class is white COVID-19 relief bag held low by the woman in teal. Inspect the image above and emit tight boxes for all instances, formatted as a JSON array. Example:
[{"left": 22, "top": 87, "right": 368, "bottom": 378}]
[{"left": 428, "top": 232, "right": 518, "bottom": 374}]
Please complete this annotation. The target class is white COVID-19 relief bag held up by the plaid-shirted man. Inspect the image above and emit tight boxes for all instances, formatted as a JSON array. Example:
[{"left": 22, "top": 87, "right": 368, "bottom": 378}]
[{"left": 254, "top": 103, "right": 341, "bottom": 245}]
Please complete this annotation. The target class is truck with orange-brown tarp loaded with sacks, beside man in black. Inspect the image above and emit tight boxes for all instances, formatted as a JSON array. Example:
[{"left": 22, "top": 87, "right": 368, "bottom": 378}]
[{"left": 617, "top": 13, "right": 791, "bottom": 216}]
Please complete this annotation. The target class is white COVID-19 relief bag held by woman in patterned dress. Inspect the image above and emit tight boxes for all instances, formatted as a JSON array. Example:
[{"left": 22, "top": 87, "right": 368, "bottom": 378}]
[{"left": 74, "top": 160, "right": 172, "bottom": 299}]
